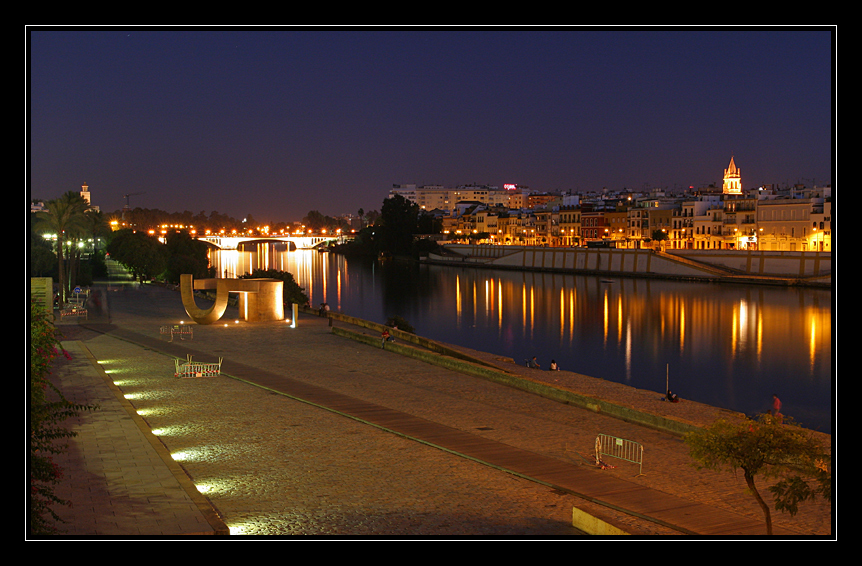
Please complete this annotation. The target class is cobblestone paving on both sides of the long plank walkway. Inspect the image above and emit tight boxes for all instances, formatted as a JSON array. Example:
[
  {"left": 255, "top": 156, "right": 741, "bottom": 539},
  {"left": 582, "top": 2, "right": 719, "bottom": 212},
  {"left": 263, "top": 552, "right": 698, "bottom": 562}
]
[{"left": 44, "top": 276, "right": 832, "bottom": 537}]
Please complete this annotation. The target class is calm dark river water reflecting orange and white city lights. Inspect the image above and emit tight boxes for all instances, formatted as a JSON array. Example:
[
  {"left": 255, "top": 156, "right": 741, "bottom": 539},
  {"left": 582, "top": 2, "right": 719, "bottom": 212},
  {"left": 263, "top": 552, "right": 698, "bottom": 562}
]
[{"left": 206, "top": 244, "right": 835, "bottom": 434}]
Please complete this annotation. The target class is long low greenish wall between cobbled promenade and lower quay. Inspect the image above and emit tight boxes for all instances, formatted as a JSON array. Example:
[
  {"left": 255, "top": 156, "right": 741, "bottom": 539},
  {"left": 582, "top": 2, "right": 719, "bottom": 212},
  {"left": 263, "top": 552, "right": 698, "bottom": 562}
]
[{"left": 308, "top": 307, "right": 724, "bottom": 437}]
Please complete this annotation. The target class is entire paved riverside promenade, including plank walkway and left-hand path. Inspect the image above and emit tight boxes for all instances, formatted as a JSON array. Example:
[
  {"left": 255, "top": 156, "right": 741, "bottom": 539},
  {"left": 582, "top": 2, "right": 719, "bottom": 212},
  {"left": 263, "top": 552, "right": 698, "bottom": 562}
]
[{"left": 42, "top": 266, "right": 833, "bottom": 539}]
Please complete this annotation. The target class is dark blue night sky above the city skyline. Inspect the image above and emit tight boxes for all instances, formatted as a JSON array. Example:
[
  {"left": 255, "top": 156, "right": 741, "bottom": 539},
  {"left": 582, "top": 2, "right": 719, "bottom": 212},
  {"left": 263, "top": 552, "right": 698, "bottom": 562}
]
[{"left": 28, "top": 28, "right": 835, "bottom": 222}]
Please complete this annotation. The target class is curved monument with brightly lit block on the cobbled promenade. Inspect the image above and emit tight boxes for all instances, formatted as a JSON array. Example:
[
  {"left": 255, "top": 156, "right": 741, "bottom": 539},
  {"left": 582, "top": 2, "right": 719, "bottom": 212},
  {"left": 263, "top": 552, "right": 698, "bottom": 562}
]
[{"left": 180, "top": 274, "right": 284, "bottom": 324}]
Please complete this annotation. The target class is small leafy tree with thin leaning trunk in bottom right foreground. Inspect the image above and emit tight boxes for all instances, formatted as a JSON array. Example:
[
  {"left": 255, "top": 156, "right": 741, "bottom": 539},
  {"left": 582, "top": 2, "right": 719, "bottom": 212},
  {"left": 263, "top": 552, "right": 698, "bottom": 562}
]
[{"left": 685, "top": 414, "right": 832, "bottom": 535}]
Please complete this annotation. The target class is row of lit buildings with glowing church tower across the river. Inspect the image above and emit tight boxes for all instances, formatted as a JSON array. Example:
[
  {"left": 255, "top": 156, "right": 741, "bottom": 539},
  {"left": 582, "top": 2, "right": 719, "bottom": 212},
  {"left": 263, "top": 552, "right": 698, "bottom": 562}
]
[{"left": 390, "top": 159, "right": 833, "bottom": 251}]
